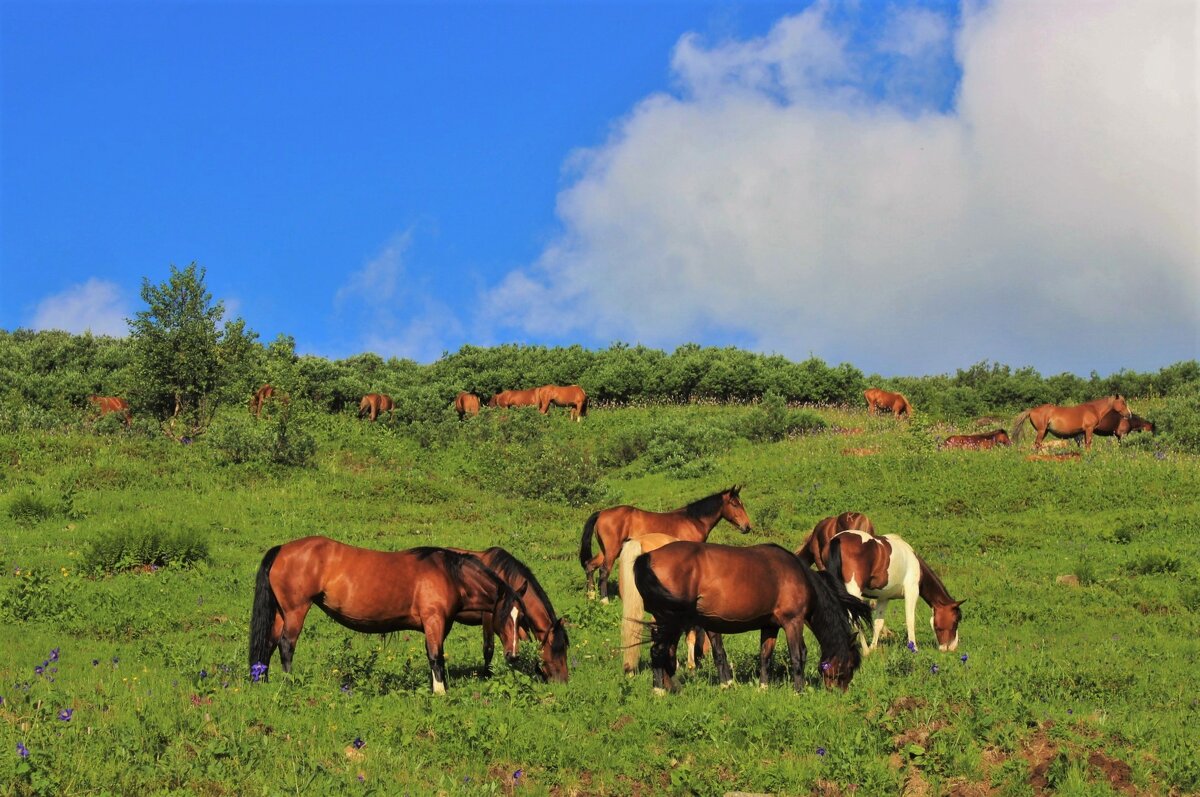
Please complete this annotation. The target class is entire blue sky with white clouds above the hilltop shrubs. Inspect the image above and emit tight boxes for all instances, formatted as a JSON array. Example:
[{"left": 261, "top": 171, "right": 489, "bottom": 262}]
[{"left": 0, "top": 0, "right": 1200, "bottom": 373}]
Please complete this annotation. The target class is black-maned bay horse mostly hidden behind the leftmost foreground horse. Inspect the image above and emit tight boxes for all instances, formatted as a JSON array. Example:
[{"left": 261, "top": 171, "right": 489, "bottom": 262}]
[{"left": 450, "top": 546, "right": 570, "bottom": 683}]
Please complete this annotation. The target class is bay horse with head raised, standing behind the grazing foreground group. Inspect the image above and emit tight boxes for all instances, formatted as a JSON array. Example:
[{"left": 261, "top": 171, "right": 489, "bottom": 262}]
[{"left": 580, "top": 485, "right": 750, "bottom": 603}]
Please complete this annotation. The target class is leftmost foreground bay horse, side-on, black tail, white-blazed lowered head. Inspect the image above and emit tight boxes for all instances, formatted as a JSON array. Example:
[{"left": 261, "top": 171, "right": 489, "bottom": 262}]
[{"left": 250, "top": 537, "right": 524, "bottom": 695}]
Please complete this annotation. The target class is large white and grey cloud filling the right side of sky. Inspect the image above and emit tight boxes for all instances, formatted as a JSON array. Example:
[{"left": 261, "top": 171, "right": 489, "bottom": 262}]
[{"left": 485, "top": 1, "right": 1200, "bottom": 373}]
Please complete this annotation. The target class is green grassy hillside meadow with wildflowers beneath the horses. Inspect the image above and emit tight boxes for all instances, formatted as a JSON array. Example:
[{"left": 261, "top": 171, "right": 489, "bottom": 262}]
[{"left": 0, "top": 402, "right": 1200, "bottom": 795}]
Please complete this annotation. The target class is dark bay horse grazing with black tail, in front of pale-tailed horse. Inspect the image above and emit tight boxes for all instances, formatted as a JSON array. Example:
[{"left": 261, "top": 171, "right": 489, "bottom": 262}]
[{"left": 634, "top": 543, "right": 871, "bottom": 691}]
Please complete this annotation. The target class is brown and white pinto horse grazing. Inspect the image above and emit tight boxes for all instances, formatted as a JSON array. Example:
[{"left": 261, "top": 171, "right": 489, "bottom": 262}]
[{"left": 826, "top": 532, "right": 962, "bottom": 654}]
